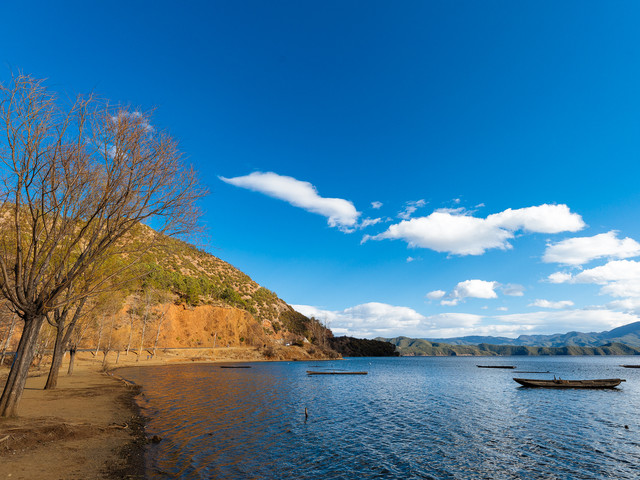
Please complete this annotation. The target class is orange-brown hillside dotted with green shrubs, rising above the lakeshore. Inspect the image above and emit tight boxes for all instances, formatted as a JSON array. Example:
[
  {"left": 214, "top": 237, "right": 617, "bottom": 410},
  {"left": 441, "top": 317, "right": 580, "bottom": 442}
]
[{"left": 0, "top": 227, "right": 336, "bottom": 356}]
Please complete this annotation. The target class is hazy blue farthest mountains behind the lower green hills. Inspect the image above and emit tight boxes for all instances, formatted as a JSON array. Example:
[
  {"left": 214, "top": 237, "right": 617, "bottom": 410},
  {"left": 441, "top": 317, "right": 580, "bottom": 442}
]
[{"left": 424, "top": 322, "right": 640, "bottom": 347}]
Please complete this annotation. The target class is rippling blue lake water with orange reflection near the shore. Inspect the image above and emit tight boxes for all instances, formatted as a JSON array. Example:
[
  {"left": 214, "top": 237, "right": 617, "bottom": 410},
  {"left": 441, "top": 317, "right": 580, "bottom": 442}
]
[{"left": 119, "top": 357, "right": 640, "bottom": 479}]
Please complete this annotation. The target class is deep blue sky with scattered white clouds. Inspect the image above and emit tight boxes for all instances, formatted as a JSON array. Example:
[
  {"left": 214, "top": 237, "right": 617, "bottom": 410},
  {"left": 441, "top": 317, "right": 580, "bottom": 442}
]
[{"left": 6, "top": 1, "right": 640, "bottom": 338}]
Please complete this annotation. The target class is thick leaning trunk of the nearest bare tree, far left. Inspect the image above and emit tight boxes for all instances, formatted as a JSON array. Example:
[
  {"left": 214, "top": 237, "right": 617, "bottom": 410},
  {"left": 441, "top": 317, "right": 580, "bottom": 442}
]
[{"left": 0, "top": 316, "right": 45, "bottom": 417}]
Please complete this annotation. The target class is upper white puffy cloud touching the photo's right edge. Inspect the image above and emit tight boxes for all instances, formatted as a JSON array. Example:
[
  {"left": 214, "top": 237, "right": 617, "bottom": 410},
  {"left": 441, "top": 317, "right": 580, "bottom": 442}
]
[{"left": 542, "top": 231, "right": 640, "bottom": 265}]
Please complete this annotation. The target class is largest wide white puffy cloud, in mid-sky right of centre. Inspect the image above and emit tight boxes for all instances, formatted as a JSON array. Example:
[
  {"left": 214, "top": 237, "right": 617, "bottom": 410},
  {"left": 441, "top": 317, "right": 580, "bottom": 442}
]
[{"left": 363, "top": 204, "right": 585, "bottom": 255}]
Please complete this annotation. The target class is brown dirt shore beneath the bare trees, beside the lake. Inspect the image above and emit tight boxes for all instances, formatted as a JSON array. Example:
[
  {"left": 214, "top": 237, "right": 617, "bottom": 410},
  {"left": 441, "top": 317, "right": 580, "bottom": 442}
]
[{"left": 0, "top": 347, "right": 330, "bottom": 480}]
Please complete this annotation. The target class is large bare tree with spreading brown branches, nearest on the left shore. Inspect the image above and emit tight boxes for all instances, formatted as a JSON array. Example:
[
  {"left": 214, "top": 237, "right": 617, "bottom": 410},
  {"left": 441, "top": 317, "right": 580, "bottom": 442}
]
[{"left": 0, "top": 75, "right": 205, "bottom": 417}]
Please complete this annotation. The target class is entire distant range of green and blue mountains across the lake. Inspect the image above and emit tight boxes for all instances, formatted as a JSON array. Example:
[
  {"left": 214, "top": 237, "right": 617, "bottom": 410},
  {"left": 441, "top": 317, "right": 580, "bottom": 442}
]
[{"left": 376, "top": 322, "right": 640, "bottom": 356}]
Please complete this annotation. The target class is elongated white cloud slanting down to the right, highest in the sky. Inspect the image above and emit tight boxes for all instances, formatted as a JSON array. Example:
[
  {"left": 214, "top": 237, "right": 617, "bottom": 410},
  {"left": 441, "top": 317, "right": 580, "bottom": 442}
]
[{"left": 219, "top": 172, "right": 360, "bottom": 232}]
